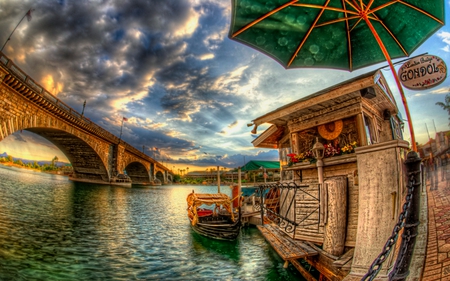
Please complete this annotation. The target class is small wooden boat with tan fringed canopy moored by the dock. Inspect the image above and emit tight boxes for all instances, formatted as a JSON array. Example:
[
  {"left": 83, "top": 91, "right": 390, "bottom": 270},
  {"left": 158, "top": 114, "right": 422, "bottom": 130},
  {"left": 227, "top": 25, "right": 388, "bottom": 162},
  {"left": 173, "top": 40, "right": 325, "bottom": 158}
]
[{"left": 187, "top": 191, "right": 241, "bottom": 240}]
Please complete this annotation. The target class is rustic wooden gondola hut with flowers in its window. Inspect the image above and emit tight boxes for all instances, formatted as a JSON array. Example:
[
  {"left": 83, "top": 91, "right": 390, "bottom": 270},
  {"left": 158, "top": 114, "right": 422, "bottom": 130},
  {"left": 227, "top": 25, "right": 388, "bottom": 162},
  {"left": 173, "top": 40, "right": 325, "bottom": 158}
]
[{"left": 253, "top": 71, "right": 420, "bottom": 280}]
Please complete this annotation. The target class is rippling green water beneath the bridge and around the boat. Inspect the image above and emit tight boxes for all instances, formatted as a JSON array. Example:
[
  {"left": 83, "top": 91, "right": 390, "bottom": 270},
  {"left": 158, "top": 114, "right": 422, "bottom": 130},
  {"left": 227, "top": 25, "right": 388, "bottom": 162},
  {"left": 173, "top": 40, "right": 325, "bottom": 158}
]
[{"left": 0, "top": 165, "right": 303, "bottom": 280}]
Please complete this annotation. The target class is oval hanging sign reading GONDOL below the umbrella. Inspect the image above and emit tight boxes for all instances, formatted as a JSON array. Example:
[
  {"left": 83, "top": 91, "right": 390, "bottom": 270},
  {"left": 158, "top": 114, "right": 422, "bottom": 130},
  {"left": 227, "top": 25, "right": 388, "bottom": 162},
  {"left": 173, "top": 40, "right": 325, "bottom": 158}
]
[{"left": 398, "top": 55, "right": 447, "bottom": 90}]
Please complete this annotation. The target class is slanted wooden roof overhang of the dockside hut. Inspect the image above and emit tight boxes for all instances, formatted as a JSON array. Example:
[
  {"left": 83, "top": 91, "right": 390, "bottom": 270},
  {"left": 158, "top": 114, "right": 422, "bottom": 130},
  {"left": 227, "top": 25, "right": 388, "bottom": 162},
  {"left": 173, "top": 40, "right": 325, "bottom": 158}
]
[{"left": 252, "top": 71, "right": 398, "bottom": 148}]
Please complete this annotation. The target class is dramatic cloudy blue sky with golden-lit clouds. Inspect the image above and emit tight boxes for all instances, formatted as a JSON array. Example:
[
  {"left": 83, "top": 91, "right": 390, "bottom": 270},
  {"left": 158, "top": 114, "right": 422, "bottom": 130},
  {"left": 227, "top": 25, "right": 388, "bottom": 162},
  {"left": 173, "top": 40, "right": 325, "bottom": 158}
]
[{"left": 0, "top": 0, "right": 450, "bottom": 171}]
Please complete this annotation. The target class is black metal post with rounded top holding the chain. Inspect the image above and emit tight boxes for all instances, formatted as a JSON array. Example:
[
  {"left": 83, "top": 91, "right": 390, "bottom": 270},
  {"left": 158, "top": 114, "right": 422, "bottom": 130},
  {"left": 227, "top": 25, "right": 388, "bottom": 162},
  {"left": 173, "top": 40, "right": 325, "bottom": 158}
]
[{"left": 389, "top": 151, "right": 421, "bottom": 280}]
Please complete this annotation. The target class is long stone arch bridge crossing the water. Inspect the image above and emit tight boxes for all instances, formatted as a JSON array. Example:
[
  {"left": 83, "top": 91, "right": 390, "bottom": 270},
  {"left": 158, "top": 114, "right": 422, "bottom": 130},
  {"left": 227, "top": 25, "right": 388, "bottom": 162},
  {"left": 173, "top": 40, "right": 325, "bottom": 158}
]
[{"left": 0, "top": 52, "right": 173, "bottom": 184}]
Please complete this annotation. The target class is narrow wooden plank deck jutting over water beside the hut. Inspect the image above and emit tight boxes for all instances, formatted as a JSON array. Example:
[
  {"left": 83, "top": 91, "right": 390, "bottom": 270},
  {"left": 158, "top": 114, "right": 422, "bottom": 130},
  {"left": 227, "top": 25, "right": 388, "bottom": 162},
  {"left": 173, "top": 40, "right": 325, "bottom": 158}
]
[{"left": 257, "top": 224, "right": 318, "bottom": 261}]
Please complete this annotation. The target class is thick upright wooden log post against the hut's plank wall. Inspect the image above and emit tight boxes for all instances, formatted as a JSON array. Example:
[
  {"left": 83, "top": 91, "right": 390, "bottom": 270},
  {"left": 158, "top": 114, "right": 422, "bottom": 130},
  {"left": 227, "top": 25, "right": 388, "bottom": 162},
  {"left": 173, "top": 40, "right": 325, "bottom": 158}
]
[{"left": 323, "top": 177, "right": 347, "bottom": 256}]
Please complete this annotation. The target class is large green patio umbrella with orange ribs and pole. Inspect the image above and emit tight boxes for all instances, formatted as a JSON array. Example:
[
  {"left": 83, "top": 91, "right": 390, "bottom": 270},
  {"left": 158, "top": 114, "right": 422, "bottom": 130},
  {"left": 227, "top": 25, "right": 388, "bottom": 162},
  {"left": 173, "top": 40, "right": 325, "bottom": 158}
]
[{"left": 229, "top": 0, "right": 444, "bottom": 151}]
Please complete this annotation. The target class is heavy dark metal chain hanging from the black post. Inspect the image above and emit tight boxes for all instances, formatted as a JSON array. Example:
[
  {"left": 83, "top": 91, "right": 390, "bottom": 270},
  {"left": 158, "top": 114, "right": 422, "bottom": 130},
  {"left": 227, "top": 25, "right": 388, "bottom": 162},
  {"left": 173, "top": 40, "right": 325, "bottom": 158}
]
[{"left": 361, "top": 172, "right": 416, "bottom": 281}]
